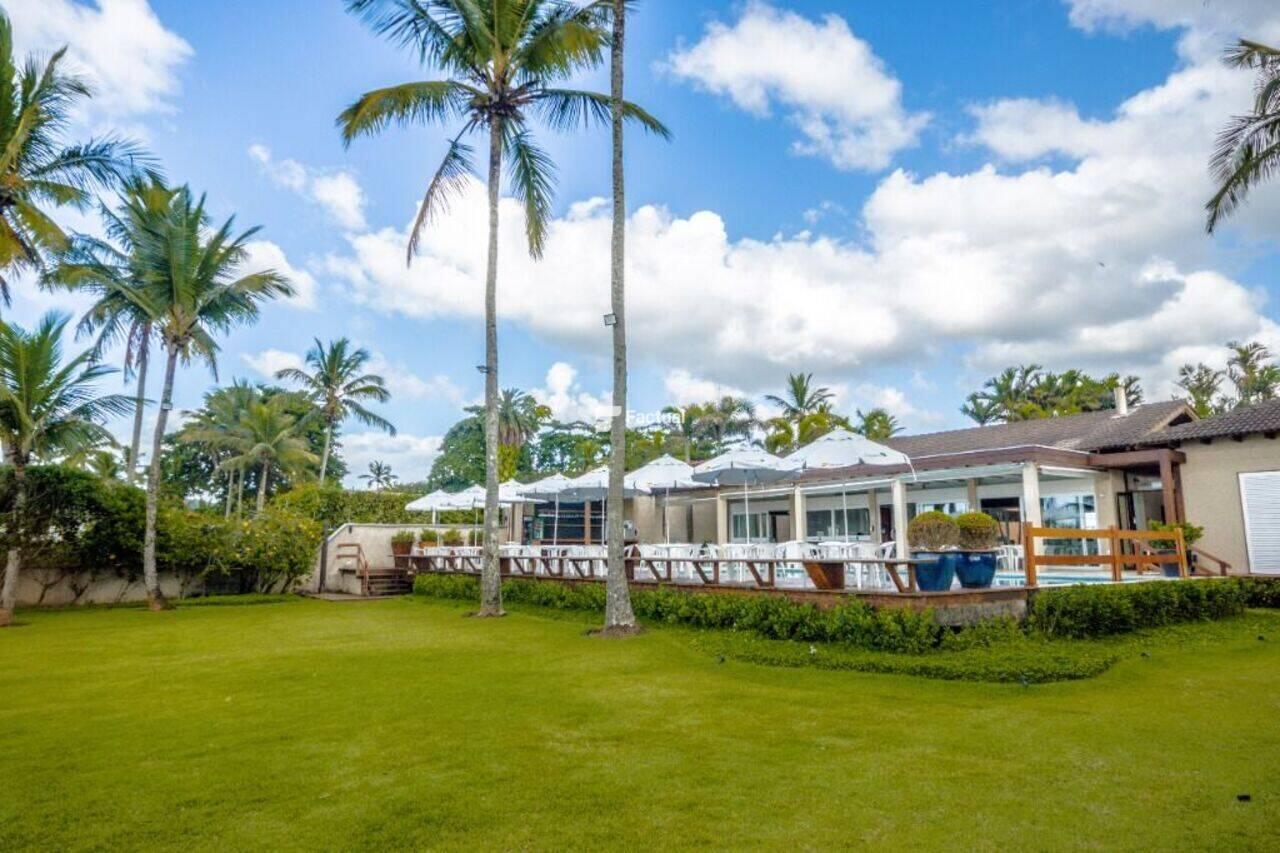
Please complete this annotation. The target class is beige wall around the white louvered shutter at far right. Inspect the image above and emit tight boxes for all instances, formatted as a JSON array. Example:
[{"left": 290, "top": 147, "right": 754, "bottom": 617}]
[{"left": 1179, "top": 435, "right": 1280, "bottom": 573}]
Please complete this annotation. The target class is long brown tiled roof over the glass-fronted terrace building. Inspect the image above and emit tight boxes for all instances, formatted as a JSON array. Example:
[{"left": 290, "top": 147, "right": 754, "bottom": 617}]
[{"left": 884, "top": 400, "right": 1194, "bottom": 460}]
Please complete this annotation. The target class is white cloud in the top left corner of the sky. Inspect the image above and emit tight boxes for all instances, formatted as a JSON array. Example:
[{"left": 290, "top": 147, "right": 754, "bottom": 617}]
[{"left": 5, "top": 0, "right": 193, "bottom": 123}]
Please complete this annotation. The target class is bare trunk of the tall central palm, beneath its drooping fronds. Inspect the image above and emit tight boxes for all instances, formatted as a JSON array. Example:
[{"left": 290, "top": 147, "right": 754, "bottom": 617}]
[{"left": 477, "top": 117, "right": 502, "bottom": 616}]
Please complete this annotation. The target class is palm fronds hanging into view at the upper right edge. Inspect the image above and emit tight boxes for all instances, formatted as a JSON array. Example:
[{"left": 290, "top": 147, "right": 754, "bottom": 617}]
[{"left": 1204, "top": 38, "right": 1280, "bottom": 234}]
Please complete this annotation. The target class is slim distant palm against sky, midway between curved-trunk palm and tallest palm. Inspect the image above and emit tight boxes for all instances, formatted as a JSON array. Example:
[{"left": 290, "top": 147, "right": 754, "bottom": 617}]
[{"left": 275, "top": 338, "right": 396, "bottom": 484}]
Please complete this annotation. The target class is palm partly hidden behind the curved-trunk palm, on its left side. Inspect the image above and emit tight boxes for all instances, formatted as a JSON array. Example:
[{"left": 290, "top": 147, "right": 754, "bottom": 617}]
[{"left": 44, "top": 177, "right": 173, "bottom": 480}]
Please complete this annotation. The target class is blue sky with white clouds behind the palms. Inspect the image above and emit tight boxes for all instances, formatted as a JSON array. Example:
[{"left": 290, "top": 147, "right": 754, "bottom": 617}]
[{"left": 0, "top": 0, "right": 1280, "bottom": 483}]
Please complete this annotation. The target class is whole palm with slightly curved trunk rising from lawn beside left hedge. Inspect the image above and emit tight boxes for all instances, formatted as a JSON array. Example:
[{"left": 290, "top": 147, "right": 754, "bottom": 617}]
[{"left": 125, "top": 187, "right": 293, "bottom": 610}]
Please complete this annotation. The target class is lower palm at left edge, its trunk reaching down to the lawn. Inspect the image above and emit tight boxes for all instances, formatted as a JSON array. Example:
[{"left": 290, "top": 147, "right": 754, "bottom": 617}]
[{"left": 0, "top": 314, "right": 129, "bottom": 626}]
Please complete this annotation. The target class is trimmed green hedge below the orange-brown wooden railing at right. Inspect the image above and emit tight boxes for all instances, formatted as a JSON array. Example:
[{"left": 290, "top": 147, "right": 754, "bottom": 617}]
[{"left": 1028, "top": 579, "right": 1247, "bottom": 639}]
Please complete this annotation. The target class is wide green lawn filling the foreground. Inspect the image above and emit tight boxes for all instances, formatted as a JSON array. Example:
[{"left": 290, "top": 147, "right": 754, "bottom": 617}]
[{"left": 0, "top": 599, "right": 1280, "bottom": 850}]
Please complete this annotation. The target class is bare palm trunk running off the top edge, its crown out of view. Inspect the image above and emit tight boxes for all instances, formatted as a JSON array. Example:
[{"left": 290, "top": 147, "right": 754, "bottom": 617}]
[{"left": 604, "top": 0, "right": 636, "bottom": 634}]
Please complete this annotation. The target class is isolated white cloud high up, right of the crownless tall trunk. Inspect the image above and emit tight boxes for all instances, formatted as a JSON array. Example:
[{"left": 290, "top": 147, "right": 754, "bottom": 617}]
[{"left": 666, "top": 1, "right": 928, "bottom": 169}]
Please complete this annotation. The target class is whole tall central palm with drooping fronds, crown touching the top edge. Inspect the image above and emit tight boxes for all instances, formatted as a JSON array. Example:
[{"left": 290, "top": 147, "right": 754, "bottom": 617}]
[{"left": 338, "top": 0, "right": 666, "bottom": 616}]
